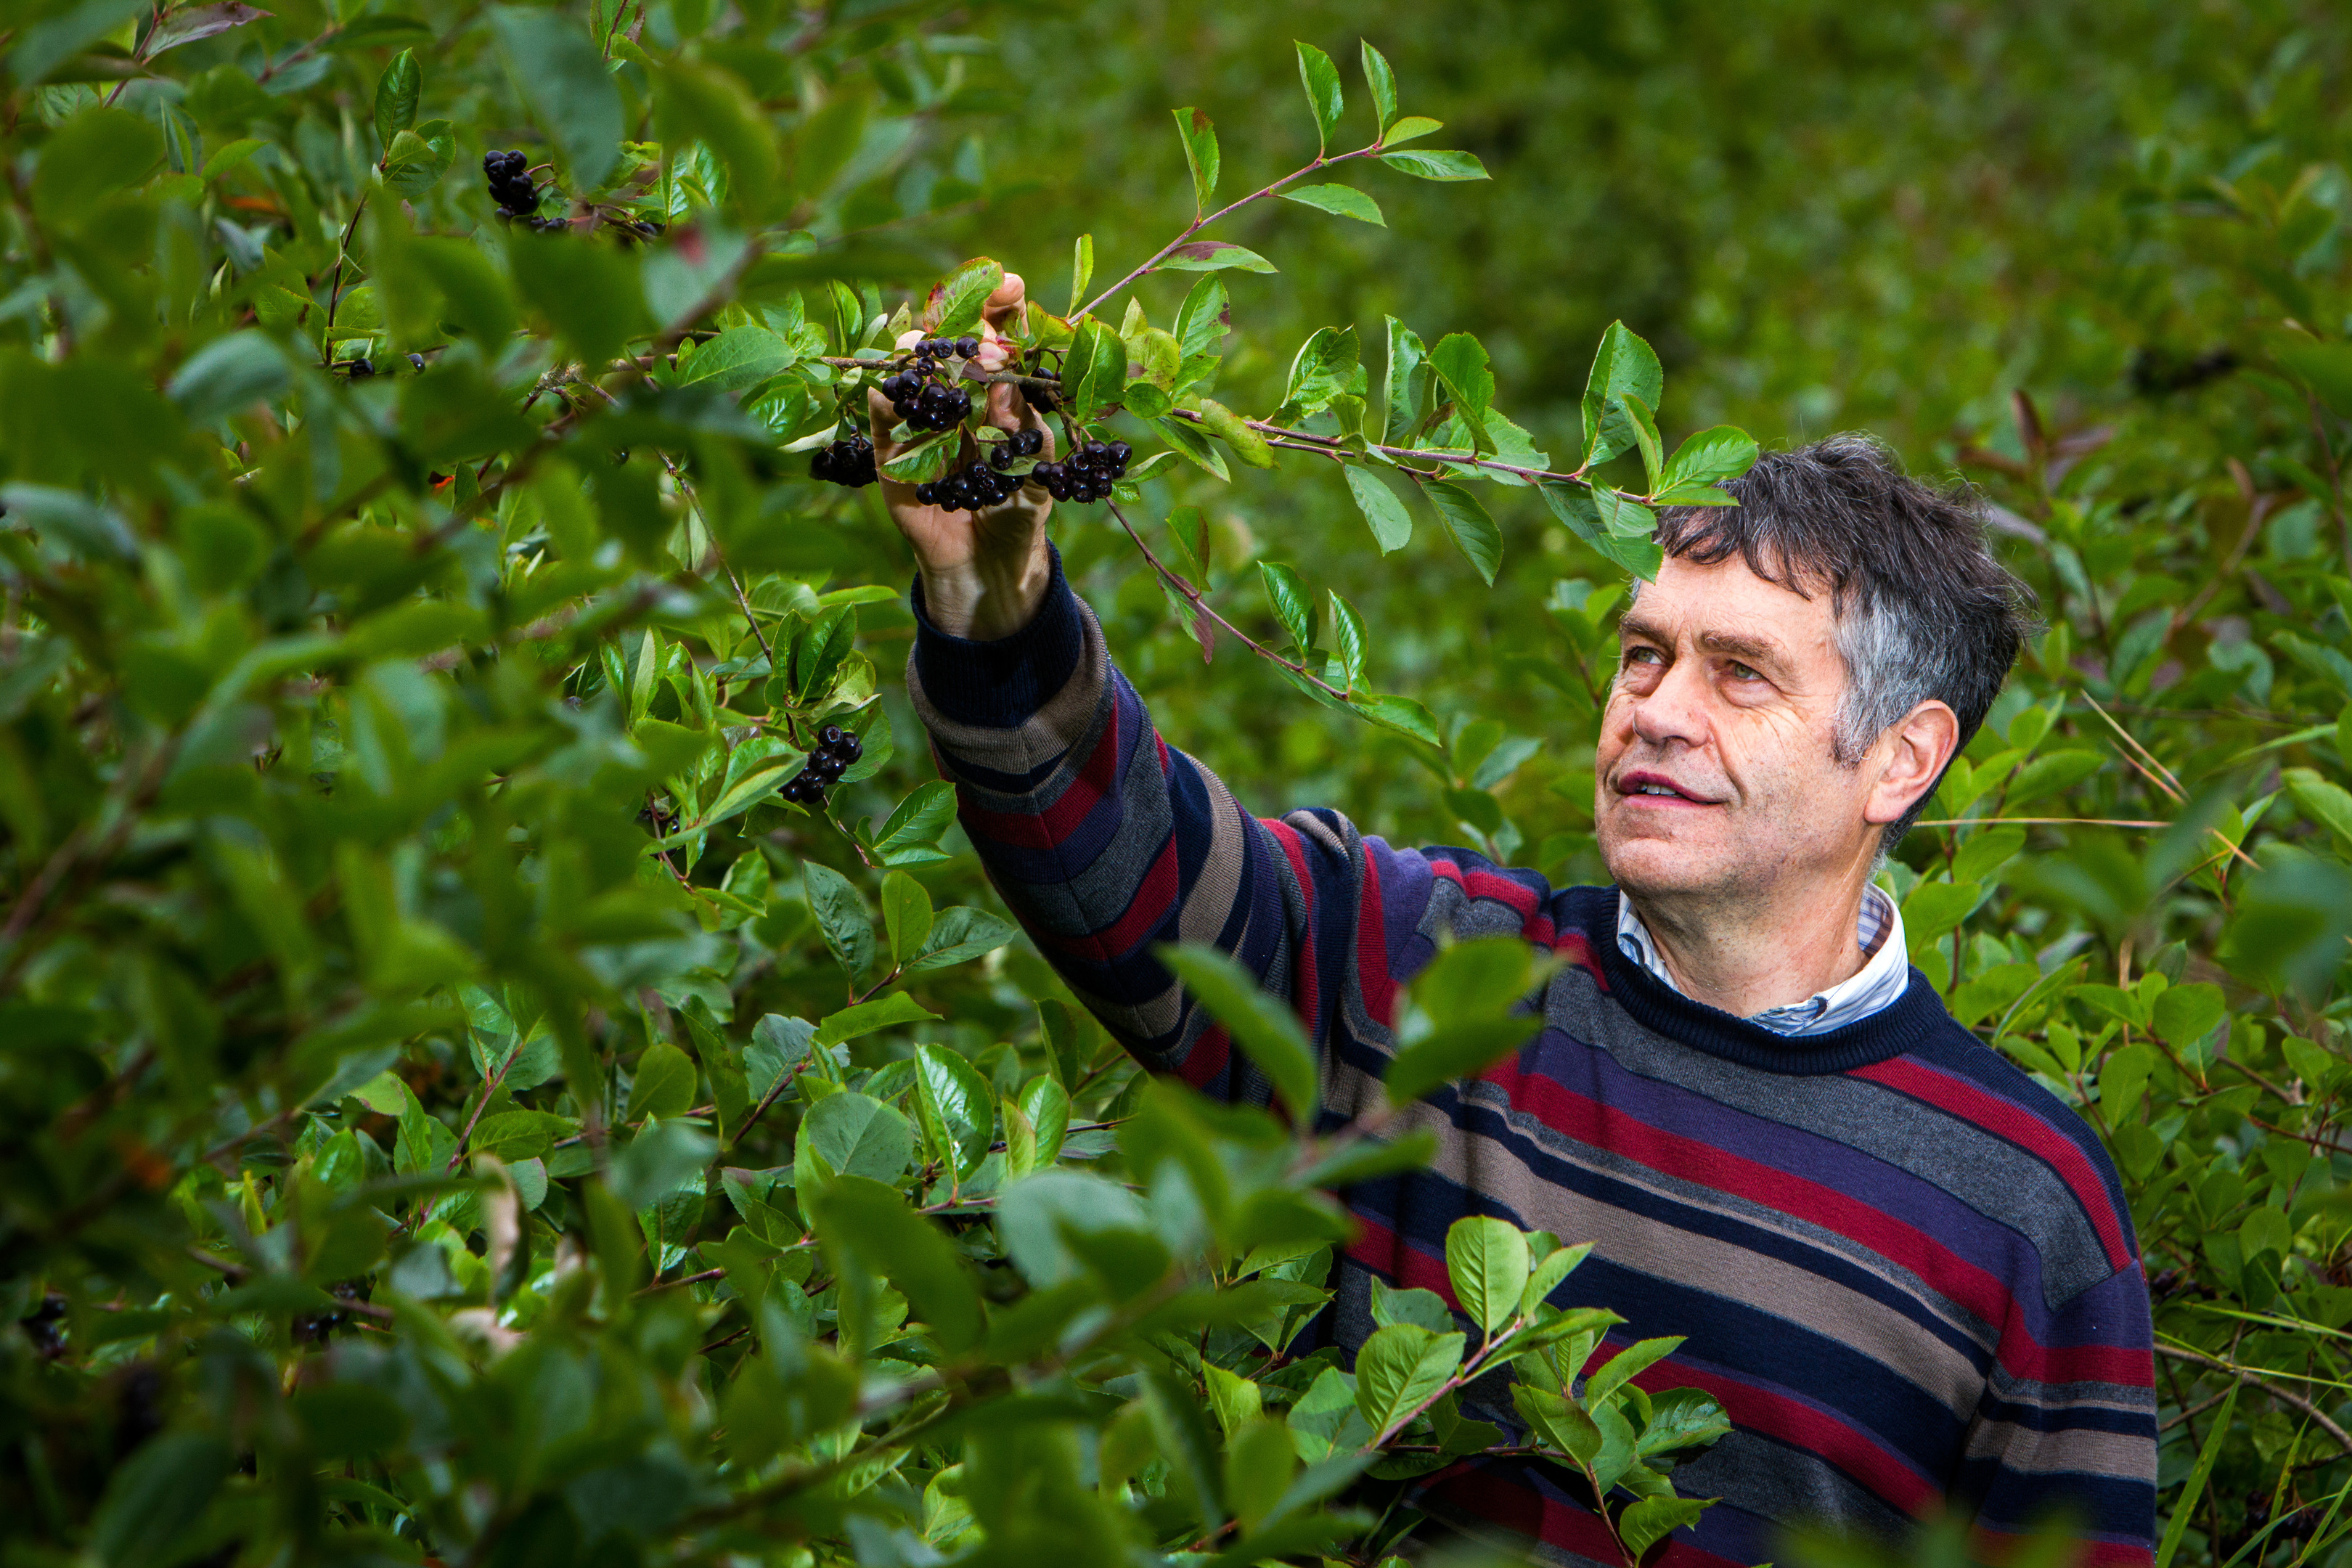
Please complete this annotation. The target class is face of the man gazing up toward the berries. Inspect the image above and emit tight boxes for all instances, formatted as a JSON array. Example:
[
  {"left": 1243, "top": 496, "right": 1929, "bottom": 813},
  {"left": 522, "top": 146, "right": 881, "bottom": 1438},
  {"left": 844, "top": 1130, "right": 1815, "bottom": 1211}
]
[{"left": 1592, "top": 555, "right": 1877, "bottom": 900}]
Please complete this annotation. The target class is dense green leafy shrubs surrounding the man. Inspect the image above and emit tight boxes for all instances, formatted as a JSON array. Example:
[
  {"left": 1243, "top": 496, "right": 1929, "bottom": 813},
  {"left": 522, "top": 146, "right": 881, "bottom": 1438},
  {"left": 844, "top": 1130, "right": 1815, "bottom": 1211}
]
[{"left": 14, "top": 0, "right": 2352, "bottom": 1564}]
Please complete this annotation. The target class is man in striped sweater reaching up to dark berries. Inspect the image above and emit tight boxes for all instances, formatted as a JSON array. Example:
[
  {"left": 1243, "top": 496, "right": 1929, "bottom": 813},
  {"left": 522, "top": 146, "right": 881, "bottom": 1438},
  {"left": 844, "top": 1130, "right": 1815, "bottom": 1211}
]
[{"left": 875, "top": 277, "right": 2157, "bottom": 1564}]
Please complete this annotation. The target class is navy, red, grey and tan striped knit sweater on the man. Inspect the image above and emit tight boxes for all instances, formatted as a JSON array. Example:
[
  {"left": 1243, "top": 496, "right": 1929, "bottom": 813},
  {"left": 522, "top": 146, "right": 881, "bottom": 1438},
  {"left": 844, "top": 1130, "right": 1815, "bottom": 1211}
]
[{"left": 908, "top": 562, "right": 2157, "bottom": 1566}]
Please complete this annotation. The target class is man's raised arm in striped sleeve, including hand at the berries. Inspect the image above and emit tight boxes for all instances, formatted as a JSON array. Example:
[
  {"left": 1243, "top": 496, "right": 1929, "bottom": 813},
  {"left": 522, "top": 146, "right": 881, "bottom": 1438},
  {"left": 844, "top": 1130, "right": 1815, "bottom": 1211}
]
[{"left": 873, "top": 277, "right": 1425, "bottom": 1101}]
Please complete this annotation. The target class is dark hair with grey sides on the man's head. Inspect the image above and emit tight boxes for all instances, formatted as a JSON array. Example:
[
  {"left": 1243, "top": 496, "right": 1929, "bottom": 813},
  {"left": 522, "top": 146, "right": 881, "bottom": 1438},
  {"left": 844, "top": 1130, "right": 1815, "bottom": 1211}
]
[{"left": 1658, "top": 435, "right": 2037, "bottom": 856}]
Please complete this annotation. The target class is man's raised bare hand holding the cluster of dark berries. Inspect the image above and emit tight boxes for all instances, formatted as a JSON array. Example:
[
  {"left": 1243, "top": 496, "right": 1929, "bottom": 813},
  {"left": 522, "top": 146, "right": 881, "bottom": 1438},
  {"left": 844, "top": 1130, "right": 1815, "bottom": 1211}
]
[{"left": 865, "top": 273, "right": 1054, "bottom": 642}]
